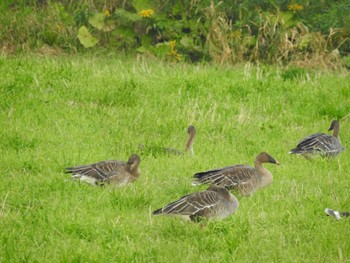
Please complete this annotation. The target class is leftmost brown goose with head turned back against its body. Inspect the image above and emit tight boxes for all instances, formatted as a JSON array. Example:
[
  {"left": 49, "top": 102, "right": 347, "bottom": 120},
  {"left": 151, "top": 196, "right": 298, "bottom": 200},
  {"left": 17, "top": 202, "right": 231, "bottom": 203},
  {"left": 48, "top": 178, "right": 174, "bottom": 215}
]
[{"left": 66, "top": 154, "right": 141, "bottom": 186}]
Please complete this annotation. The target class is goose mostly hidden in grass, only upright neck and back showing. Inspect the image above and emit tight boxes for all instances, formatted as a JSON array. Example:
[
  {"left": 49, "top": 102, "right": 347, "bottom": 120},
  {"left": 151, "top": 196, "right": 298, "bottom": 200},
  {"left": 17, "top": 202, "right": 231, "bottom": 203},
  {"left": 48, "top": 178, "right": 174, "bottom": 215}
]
[{"left": 139, "top": 125, "right": 196, "bottom": 155}]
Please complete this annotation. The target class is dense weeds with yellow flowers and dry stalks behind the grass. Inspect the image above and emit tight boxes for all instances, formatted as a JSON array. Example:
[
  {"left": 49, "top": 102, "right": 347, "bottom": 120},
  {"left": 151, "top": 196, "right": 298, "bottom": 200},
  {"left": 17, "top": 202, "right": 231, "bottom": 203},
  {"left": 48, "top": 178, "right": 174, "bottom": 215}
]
[{"left": 0, "top": 0, "right": 350, "bottom": 68}]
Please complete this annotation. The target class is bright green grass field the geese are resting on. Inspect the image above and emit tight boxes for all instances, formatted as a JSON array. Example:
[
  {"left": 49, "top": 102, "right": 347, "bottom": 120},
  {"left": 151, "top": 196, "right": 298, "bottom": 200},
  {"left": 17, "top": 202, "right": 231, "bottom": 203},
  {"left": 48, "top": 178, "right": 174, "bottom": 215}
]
[{"left": 0, "top": 56, "right": 350, "bottom": 262}]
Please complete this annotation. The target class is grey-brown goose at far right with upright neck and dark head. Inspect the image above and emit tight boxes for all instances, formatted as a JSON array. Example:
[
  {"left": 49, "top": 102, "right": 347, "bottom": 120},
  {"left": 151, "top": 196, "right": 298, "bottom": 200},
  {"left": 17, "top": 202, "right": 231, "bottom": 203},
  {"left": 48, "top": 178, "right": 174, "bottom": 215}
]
[{"left": 289, "top": 120, "right": 344, "bottom": 159}]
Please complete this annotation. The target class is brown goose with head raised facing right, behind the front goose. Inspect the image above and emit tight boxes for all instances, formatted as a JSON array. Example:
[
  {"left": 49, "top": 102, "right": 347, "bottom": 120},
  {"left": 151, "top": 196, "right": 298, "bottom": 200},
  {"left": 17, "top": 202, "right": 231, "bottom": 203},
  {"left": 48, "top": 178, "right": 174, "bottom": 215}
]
[{"left": 192, "top": 152, "right": 279, "bottom": 195}]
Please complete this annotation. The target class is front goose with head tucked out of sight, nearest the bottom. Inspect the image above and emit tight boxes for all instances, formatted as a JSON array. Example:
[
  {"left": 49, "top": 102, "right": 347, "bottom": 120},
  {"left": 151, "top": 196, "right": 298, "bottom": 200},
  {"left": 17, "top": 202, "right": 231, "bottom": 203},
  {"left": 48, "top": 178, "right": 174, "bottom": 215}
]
[{"left": 153, "top": 185, "right": 239, "bottom": 221}]
